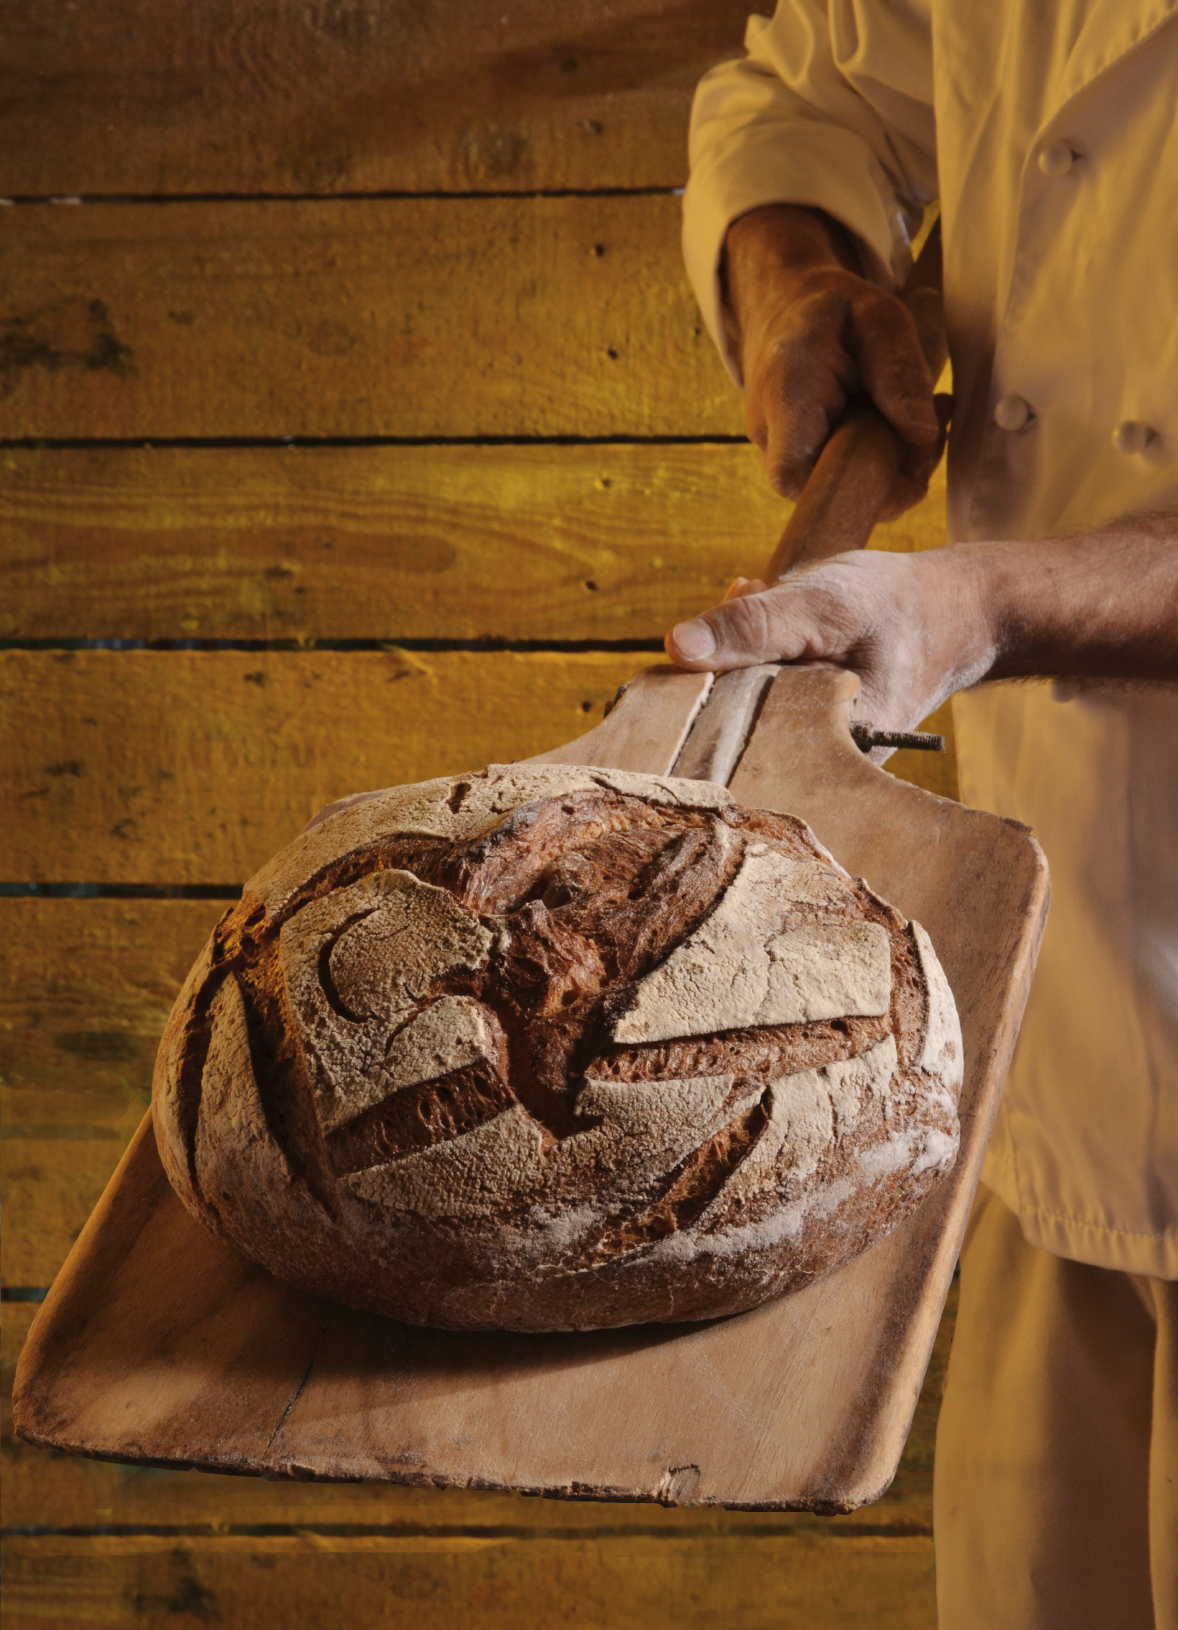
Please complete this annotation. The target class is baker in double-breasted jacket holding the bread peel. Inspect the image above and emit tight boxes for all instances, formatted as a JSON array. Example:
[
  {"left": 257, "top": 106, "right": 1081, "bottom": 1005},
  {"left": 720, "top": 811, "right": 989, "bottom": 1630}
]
[{"left": 668, "top": 0, "right": 1178, "bottom": 1630}]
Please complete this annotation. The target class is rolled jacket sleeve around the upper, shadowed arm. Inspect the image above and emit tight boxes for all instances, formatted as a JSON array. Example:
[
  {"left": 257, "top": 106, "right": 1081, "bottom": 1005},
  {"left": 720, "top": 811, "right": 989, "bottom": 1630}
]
[{"left": 683, "top": 0, "right": 937, "bottom": 385}]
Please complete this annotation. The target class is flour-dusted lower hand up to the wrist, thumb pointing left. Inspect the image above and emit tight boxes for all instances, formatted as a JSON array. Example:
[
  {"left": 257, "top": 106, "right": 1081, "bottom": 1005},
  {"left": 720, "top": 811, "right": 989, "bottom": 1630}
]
[{"left": 666, "top": 548, "right": 997, "bottom": 730}]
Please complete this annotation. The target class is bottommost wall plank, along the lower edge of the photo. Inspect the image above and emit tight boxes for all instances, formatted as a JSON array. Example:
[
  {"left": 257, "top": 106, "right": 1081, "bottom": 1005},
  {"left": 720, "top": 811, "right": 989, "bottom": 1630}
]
[{"left": 5, "top": 1534, "right": 937, "bottom": 1630}]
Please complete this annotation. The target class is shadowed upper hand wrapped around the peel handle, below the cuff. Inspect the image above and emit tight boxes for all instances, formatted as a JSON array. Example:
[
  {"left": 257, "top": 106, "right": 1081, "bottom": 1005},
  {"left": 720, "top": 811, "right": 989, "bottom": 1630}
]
[{"left": 723, "top": 204, "right": 950, "bottom": 520}]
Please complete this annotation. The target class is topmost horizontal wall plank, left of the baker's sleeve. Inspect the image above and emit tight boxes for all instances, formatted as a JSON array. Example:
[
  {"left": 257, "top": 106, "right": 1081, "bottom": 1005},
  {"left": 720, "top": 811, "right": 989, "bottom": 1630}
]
[{"left": 0, "top": 0, "right": 748, "bottom": 196}]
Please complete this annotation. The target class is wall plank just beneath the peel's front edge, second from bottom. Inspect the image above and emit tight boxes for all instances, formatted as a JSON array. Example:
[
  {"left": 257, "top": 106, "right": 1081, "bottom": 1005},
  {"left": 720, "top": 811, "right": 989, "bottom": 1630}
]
[{"left": 0, "top": 1293, "right": 956, "bottom": 1539}]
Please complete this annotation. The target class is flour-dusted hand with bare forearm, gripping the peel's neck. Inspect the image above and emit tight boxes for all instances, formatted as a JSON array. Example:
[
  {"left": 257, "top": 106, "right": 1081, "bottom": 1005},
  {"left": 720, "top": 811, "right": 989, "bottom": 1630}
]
[{"left": 666, "top": 515, "right": 1178, "bottom": 730}]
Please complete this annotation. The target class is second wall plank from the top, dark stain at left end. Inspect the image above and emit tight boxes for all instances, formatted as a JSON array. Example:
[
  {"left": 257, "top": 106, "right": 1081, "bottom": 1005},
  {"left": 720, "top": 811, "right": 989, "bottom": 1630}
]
[{"left": 0, "top": 196, "right": 743, "bottom": 440}]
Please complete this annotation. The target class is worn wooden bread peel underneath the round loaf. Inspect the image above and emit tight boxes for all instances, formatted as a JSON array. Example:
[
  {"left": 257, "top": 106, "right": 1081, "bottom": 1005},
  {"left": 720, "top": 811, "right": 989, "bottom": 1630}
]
[{"left": 15, "top": 223, "right": 1048, "bottom": 1511}]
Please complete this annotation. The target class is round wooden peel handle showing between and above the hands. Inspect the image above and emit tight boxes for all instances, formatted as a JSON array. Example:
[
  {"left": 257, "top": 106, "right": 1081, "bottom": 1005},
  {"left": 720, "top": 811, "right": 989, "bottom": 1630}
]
[{"left": 764, "top": 220, "right": 947, "bottom": 584}]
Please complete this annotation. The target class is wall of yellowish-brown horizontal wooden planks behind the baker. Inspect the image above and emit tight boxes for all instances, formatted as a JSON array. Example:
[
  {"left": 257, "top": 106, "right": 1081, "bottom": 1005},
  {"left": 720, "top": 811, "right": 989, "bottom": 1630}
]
[{"left": 0, "top": 0, "right": 955, "bottom": 1630}]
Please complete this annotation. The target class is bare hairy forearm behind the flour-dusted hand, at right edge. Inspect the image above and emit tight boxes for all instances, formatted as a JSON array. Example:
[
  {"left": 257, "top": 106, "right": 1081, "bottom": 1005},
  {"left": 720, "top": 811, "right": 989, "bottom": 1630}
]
[{"left": 951, "top": 517, "right": 1178, "bottom": 680}]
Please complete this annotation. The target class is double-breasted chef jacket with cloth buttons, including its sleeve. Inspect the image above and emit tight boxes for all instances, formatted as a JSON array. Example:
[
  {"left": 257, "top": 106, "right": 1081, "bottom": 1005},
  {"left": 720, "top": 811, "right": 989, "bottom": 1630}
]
[{"left": 683, "top": 0, "right": 1178, "bottom": 1278}]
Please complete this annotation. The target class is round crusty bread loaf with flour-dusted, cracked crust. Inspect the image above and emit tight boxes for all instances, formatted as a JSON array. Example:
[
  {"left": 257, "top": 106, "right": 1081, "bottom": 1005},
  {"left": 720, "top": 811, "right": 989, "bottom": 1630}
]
[{"left": 155, "top": 764, "right": 961, "bottom": 1330}]
